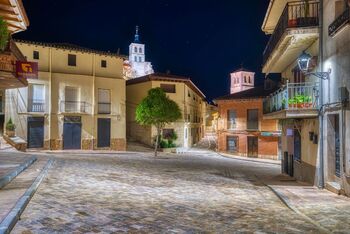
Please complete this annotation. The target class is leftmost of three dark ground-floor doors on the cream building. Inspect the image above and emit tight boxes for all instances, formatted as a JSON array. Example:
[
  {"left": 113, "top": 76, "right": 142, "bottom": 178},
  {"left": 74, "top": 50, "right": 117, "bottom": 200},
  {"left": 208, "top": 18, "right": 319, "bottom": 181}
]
[{"left": 27, "top": 117, "right": 44, "bottom": 148}]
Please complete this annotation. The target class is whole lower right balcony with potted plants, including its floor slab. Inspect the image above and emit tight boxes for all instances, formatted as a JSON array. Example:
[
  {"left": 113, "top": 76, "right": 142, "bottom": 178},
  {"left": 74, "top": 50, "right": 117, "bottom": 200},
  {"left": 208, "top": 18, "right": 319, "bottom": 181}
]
[{"left": 263, "top": 82, "right": 319, "bottom": 119}]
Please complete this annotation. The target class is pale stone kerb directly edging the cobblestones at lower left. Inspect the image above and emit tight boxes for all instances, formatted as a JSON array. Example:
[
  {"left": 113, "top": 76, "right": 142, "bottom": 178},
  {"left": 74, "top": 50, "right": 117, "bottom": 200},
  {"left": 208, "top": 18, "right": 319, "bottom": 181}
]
[{"left": 0, "top": 159, "right": 54, "bottom": 234}]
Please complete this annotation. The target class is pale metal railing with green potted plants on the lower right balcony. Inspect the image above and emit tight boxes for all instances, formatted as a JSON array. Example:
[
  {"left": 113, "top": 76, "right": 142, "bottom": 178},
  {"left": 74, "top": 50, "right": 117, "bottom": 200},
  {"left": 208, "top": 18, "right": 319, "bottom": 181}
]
[{"left": 264, "top": 82, "right": 319, "bottom": 114}]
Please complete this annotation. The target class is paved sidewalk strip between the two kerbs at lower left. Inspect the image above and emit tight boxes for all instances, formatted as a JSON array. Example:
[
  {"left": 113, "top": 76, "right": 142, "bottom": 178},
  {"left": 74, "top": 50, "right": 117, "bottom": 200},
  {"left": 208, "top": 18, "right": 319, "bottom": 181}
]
[{"left": 0, "top": 156, "right": 48, "bottom": 223}]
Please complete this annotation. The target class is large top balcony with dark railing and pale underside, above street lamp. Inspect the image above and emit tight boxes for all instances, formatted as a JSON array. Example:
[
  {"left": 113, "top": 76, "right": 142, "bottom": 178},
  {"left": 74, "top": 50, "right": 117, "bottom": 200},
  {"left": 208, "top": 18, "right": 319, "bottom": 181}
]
[{"left": 263, "top": 1, "right": 319, "bottom": 73}]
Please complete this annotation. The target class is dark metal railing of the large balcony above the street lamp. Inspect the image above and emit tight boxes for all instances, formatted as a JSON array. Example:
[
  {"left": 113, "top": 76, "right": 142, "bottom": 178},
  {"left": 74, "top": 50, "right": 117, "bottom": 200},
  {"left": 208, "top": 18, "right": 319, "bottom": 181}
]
[{"left": 263, "top": 1, "right": 319, "bottom": 64}]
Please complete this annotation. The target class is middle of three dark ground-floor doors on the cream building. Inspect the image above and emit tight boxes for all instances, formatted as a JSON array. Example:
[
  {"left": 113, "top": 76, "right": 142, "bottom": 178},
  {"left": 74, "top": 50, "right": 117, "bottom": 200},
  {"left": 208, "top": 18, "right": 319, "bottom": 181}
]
[{"left": 63, "top": 118, "right": 81, "bottom": 149}]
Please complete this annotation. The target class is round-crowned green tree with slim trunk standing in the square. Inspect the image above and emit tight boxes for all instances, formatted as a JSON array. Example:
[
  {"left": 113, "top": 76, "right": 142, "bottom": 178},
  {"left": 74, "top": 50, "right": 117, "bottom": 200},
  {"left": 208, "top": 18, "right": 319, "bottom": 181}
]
[{"left": 136, "top": 88, "right": 182, "bottom": 157}]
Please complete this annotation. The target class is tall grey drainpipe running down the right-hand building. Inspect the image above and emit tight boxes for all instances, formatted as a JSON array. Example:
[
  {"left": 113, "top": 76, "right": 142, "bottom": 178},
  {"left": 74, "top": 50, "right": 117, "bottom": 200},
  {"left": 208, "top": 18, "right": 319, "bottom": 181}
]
[{"left": 318, "top": 0, "right": 325, "bottom": 189}]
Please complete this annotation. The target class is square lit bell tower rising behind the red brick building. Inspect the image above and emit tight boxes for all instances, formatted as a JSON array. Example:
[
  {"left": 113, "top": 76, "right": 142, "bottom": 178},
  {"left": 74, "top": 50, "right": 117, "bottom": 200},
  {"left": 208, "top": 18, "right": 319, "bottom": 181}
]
[{"left": 230, "top": 68, "right": 255, "bottom": 94}]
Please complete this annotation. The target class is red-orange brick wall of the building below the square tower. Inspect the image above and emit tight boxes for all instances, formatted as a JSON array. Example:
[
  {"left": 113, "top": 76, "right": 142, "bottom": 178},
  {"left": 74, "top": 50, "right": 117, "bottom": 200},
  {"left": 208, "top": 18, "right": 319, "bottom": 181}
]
[{"left": 218, "top": 99, "right": 278, "bottom": 159}]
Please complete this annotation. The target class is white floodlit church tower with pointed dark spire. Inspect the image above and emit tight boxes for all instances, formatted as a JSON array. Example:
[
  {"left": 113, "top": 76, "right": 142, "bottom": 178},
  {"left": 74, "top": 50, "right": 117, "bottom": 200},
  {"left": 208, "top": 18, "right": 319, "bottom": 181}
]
[{"left": 124, "top": 27, "right": 154, "bottom": 80}]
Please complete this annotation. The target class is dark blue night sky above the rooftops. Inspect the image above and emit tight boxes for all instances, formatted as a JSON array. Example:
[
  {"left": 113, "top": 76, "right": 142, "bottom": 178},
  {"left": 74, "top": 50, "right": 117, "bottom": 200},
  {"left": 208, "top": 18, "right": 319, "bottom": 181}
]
[{"left": 15, "top": 0, "right": 269, "bottom": 100}]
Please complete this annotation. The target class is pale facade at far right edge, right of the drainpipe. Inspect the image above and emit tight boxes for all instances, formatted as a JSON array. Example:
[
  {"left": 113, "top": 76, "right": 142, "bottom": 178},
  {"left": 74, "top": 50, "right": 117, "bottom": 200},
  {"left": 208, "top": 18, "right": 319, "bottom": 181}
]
[{"left": 322, "top": 0, "right": 350, "bottom": 195}]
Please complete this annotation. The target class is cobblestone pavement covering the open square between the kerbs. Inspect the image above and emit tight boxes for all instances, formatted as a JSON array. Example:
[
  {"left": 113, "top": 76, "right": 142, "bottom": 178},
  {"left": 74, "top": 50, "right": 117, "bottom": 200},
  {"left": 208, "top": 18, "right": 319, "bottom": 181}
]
[{"left": 13, "top": 151, "right": 330, "bottom": 233}]
